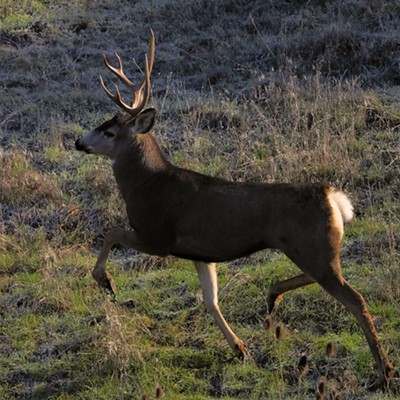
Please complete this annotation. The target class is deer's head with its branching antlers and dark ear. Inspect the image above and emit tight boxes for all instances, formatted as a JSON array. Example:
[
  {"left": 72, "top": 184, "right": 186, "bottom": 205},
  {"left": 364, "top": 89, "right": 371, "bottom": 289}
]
[{"left": 75, "top": 29, "right": 155, "bottom": 159}]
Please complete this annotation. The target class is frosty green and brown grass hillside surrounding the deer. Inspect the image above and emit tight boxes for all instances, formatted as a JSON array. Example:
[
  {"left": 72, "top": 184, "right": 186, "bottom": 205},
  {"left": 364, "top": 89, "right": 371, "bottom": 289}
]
[{"left": 0, "top": 0, "right": 400, "bottom": 400}]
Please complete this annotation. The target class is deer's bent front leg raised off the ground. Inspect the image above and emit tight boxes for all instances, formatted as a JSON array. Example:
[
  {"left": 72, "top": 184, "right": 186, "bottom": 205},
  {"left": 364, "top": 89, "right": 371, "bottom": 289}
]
[{"left": 92, "top": 229, "right": 164, "bottom": 294}]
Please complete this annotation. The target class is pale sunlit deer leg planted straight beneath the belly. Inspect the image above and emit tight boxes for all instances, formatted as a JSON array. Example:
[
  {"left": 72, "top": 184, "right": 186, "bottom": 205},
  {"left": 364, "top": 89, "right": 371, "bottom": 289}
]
[{"left": 194, "top": 261, "right": 247, "bottom": 358}]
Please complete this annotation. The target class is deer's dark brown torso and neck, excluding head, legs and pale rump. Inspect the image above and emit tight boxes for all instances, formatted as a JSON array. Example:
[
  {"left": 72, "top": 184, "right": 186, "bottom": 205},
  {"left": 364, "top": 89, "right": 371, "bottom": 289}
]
[{"left": 113, "top": 134, "right": 330, "bottom": 262}]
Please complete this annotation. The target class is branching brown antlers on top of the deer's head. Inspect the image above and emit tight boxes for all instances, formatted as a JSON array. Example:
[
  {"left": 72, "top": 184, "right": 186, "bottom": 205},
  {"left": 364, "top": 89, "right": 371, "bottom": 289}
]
[{"left": 100, "top": 28, "right": 155, "bottom": 117}]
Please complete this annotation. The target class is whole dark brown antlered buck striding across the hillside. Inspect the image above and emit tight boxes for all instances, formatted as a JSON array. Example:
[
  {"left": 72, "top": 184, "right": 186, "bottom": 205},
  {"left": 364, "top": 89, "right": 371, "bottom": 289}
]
[{"left": 75, "top": 29, "right": 394, "bottom": 387}]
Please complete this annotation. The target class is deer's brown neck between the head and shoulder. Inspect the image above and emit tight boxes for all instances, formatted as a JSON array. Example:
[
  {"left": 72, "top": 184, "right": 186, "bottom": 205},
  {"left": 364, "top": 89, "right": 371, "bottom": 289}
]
[{"left": 113, "top": 133, "right": 171, "bottom": 203}]
